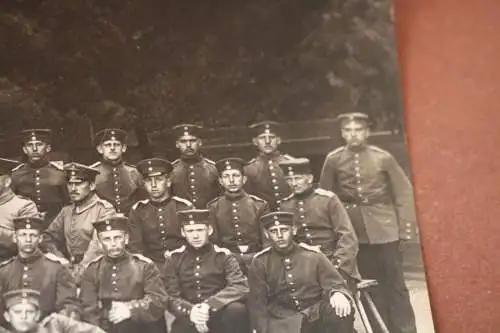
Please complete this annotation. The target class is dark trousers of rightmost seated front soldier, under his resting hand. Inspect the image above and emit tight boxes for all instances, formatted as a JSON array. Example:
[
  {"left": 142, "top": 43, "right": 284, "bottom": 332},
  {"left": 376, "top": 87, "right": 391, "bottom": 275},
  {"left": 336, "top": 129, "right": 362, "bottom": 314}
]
[{"left": 300, "top": 302, "right": 354, "bottom": 333}]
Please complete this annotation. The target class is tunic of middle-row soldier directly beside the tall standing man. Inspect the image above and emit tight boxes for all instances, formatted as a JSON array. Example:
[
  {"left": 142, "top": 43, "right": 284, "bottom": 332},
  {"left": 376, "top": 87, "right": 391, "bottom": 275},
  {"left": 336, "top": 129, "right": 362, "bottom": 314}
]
[{"left": 280, "top": 188, "right": 360, "bottom": 279}]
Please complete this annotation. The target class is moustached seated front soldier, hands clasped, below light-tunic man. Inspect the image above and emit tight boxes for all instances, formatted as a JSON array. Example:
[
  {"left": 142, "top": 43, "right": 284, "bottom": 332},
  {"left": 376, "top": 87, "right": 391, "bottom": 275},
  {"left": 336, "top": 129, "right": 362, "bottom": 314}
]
[{"left": 80, "top": 215, "right": 167, "bottom": 333}]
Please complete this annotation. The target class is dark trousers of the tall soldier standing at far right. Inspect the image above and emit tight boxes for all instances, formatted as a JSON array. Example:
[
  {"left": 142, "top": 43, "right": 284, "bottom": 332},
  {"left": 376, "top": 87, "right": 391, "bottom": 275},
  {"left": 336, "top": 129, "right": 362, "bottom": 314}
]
[{"left": 358, "top": 241, "right": 417, "bottom": 333}]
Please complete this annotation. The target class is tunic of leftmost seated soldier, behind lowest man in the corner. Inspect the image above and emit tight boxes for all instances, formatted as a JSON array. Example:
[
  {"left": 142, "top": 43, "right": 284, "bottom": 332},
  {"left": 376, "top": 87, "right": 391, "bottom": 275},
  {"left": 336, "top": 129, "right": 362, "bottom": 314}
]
[{"left": 0, "top": 251, "right": 80, "bottom": 318}]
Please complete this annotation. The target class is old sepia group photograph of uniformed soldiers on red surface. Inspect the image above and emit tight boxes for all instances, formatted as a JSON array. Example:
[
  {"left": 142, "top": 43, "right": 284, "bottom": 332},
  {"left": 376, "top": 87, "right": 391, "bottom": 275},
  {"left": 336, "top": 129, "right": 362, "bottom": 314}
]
[{"left": 0, "top": 0, "right": 434, "bottom": 333}]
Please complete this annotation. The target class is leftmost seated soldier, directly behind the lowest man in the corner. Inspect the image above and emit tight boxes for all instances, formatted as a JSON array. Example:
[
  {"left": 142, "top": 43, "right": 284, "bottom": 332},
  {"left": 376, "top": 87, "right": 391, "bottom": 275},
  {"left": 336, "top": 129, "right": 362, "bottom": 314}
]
[{"left": 0, "top": 217, "right": 80, "bottom": 318}]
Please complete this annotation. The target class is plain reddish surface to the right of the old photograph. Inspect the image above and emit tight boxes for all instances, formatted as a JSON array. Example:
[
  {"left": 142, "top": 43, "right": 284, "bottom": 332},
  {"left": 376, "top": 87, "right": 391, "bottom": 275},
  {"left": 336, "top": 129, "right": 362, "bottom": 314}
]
[{"left": 396, "top": 0, "right": 500, "bottom": 333}]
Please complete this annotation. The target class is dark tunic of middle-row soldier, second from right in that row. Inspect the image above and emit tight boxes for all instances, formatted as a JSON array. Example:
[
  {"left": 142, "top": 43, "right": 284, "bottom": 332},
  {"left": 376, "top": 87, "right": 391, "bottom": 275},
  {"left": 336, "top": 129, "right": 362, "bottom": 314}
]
[{"left": 208, "top": 191, "right": 269, "bottom": 253}]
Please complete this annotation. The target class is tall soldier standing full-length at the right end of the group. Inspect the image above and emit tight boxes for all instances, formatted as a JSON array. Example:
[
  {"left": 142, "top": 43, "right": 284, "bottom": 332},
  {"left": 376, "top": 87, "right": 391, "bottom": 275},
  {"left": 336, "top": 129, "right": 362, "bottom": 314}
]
[{"left": 320, "top": 113, "right": 416, "bottom": 333}]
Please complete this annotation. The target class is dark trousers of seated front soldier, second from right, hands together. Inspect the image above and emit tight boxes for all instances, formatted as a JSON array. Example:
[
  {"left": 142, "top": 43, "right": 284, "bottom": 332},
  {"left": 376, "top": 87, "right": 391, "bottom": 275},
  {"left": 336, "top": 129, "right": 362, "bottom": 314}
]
[{"left": 172, "top": 302, "right": 250, "bottom": 333}]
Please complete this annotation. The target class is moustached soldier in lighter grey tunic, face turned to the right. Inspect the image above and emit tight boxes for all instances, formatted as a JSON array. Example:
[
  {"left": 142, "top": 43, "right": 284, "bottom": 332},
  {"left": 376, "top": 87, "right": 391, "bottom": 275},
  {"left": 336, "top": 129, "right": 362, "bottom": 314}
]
[{"left": 41, "top": 162, "right": 116, "bottom": 281}]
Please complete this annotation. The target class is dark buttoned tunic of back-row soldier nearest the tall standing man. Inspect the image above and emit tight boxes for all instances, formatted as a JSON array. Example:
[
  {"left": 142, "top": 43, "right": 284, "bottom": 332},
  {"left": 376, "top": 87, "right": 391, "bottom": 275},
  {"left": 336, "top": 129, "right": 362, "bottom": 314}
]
[{"left": 244, "top": 152, "right": 292, "bottom": 210}]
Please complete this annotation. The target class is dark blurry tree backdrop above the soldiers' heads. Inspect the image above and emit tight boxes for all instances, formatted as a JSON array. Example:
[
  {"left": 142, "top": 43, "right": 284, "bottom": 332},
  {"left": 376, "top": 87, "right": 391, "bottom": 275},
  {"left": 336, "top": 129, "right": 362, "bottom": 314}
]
[{"left": 0, "top": 0, "right": 405, "bottom": 169}]
